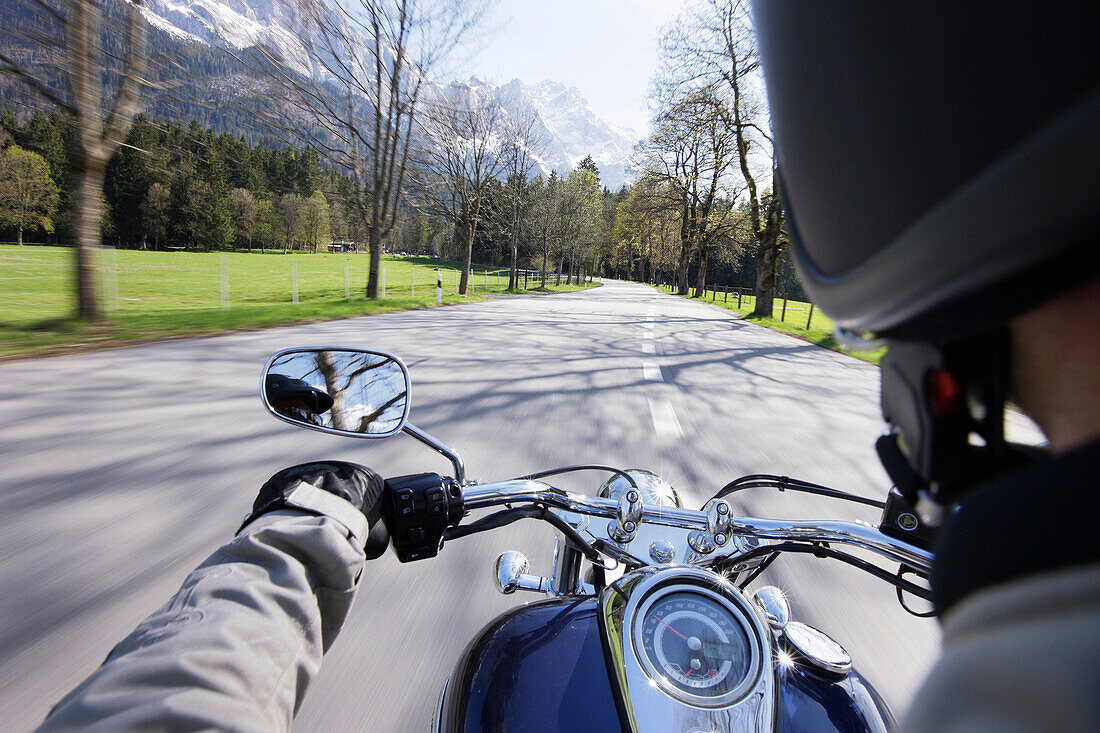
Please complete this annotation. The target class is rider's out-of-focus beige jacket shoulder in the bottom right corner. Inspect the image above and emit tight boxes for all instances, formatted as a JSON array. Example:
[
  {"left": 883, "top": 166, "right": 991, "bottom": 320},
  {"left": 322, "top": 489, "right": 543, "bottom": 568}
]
[{"left": 901, "top": 566, "right": 1100, "bottom": 733}]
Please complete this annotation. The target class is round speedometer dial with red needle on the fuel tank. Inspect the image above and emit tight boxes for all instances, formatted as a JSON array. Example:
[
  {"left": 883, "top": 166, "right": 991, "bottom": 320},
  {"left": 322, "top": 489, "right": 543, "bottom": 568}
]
[{"left": 635, "top": 587, "right": 757, "bottom": 707}]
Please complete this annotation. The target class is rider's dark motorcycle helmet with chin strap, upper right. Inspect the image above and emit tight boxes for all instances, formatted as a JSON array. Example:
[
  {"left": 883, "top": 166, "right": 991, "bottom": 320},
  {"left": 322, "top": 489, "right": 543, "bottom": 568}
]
[{"left": 752, "top": 1, "right": 1100, "bottom": 510}]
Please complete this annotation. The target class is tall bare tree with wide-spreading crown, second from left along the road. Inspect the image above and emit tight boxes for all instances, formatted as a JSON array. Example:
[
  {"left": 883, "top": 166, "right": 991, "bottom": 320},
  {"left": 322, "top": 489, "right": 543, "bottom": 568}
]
[{"left": 259, "top": 0, "right": 488, "bottom": 298}]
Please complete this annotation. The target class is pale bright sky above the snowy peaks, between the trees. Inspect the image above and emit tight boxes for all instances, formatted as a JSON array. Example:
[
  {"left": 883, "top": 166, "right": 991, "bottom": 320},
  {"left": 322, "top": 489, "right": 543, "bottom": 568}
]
[{"left": 454, "top": 0, "right": 682, "bottom": 138}]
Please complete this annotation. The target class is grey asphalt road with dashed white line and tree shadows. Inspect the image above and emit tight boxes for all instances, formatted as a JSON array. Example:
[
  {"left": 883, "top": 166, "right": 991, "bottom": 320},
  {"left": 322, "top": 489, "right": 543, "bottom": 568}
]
[{"left": 0, "top": 278, "right": 981, "bottom": 731}]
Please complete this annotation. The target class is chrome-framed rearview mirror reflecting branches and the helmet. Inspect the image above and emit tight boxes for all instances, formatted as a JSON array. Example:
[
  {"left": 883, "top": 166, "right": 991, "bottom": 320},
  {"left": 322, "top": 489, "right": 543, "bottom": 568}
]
[{"left": 260, "top": 347, "right": 409, "bottom": 438}]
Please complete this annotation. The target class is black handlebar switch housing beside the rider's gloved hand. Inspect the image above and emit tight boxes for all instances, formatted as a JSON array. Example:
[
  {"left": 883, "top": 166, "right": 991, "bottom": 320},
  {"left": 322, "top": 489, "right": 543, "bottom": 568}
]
[{"left": 382, "top": 473, "right": 464, "bottom": 562}]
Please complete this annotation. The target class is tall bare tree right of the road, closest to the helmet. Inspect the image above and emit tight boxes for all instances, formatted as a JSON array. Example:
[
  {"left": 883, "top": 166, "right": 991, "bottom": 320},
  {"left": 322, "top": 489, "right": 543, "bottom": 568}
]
[{"left": 663, "top": 0, "right": 785, "bottom": 316}]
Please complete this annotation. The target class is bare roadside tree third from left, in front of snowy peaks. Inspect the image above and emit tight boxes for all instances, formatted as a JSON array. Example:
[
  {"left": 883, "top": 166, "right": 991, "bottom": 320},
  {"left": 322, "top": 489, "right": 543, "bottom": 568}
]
[{"left": 418, "top": 85, "right": 502, "bottom": 295}]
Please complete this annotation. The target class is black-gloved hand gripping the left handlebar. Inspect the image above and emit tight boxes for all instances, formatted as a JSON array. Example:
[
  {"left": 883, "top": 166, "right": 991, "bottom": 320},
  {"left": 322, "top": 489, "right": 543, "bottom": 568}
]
[{"left": 241, "top": 461, "right": 389, "bottom": 560}]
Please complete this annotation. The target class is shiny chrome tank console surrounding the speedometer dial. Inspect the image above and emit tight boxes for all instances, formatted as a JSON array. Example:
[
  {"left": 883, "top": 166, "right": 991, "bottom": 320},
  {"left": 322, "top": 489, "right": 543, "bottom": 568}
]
[{"left": 600, "top": 566, "right": 778, "bottom": 733}]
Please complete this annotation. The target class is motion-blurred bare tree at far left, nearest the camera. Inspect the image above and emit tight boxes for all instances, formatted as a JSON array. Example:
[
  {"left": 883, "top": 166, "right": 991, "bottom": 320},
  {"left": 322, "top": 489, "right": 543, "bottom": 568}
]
[{"left": 0, "top": 0, "right": 147, "bottom": 320}]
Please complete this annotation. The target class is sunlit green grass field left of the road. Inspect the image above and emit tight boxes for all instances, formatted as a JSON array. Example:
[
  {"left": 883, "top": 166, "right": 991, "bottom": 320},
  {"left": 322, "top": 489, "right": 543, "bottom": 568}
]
[{"left": 0, "top": 245, "right": 592, "bottom": 357}]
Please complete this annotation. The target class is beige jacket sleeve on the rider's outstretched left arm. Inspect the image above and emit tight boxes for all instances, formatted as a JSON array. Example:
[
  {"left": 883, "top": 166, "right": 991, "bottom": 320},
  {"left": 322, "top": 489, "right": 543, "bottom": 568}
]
[{"left": 39, "top": 504, "right": 363, "bottom": 732}]
